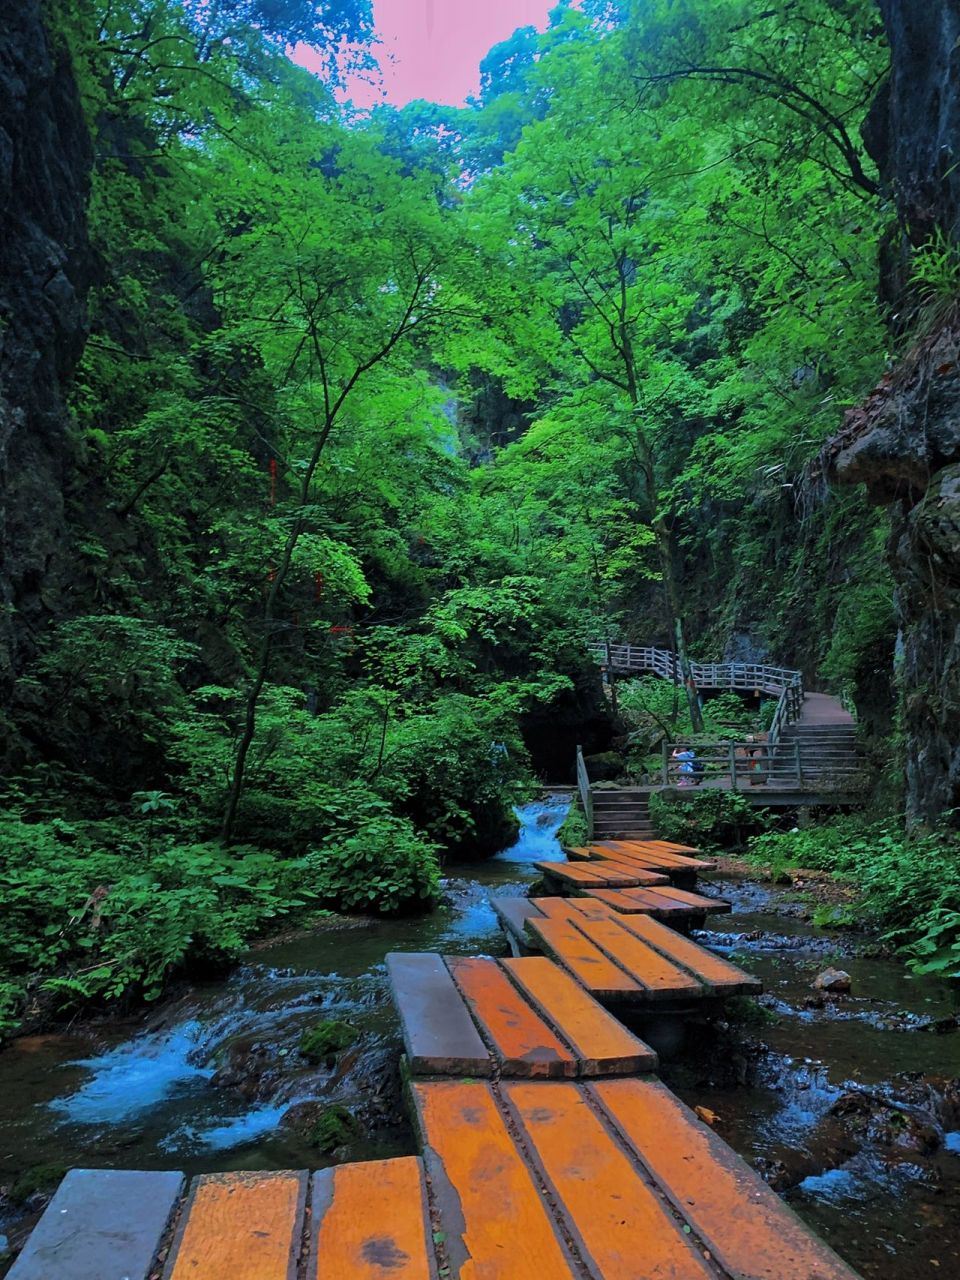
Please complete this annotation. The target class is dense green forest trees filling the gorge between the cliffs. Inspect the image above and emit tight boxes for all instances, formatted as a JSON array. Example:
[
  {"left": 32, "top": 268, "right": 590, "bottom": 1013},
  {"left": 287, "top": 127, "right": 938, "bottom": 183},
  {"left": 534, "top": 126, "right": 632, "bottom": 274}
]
[{"left": 3, "top": 0, "right": 956, "bottom": 1029}]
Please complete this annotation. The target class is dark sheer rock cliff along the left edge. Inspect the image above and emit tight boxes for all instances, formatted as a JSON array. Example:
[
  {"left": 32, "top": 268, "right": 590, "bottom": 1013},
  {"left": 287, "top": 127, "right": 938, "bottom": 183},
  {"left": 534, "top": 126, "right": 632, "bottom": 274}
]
[{"left": 0, "top": 0, "right": 91, "bottom": 696}]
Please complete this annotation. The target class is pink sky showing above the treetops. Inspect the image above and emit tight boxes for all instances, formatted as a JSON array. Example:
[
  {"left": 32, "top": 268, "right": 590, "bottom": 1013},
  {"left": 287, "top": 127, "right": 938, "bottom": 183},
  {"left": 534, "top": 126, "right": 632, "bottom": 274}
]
[{"left": 294, "top": 0, "right": 556, "bottom": 108}]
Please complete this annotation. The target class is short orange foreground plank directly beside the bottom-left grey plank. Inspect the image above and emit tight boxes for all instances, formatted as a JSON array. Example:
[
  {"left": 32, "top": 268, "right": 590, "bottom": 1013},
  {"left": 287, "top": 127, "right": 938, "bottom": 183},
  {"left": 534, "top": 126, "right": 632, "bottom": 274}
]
[{"left": 164, "top": 1172, "right": 307, "bottom": 1280}]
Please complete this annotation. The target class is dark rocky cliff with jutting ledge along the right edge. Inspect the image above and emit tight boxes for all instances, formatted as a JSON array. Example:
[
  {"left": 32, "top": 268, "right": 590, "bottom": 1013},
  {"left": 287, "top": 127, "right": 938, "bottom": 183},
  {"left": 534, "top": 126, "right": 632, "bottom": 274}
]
[{"left": 828, "top": 0, "right": 960, "bottom": 822}]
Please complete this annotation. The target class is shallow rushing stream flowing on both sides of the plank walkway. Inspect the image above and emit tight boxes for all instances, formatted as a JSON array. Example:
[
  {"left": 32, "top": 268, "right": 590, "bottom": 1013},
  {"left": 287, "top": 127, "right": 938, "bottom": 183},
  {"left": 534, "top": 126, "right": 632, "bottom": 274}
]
[{"left": 0, "top": 796, "right": 960, "bottom": 1280}]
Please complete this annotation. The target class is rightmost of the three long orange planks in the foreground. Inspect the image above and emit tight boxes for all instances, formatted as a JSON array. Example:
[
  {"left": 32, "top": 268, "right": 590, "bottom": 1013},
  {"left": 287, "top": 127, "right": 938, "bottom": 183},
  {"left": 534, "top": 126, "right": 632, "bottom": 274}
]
[{"left": 599, "top": 1080, "right": 856, "bottom": 1280}]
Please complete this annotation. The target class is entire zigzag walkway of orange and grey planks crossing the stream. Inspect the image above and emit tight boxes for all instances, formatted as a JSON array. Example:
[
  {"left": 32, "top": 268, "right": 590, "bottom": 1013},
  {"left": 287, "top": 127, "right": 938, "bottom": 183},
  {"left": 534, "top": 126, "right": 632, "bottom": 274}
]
[{"left": 10, "top": 819, "right": 856, "bottom": 1280}]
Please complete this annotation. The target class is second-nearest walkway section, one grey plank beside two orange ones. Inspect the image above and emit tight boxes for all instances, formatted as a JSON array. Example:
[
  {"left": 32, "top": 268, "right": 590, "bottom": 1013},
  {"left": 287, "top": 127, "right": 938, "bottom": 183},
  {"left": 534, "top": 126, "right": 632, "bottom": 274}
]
[{"left": 387, "top": 952, "right": 657, "bottom": 1079}]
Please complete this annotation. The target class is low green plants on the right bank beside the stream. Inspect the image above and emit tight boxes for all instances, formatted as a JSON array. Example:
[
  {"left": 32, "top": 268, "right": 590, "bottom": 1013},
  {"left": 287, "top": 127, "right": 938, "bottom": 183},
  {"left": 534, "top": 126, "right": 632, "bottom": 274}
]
[{"left": 749, "top": 817, "right": 960, "bottom": 978}]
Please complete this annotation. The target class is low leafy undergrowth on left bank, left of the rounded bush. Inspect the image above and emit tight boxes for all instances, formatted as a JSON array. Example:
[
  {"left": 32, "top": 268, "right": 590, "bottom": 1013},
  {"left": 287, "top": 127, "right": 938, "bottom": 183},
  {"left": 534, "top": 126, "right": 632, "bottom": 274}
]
[{"left": 0, "top": 814, "right": 317, "bottom": 1029}]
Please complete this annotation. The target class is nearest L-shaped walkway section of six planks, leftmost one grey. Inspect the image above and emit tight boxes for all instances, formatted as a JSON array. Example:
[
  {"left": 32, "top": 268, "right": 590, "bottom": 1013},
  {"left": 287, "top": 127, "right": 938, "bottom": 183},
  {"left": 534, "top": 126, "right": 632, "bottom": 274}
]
[{"left": 9, "top": 1079, "right": 856, "bottom": 1280}]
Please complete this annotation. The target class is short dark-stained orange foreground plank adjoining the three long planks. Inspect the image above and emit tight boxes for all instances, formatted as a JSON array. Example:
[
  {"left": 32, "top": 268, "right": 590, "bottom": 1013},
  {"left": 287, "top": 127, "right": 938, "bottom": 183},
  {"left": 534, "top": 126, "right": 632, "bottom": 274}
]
[{"left": 305, "top": 1156, "right": 436, "bottom": 1280}]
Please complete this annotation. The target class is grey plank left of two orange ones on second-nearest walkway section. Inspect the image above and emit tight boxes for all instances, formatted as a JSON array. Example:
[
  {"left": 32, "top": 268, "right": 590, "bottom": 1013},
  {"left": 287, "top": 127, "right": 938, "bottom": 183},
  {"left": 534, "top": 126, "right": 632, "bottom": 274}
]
[{"left": 387, "top": 951, "right": 493, "bottom": 1075}]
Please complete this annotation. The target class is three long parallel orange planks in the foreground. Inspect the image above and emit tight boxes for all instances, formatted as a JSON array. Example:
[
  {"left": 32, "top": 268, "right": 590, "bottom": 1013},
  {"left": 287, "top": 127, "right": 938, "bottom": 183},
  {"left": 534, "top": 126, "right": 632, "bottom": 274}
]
[{"left": 411, "top": 1079, "right": 855, "bottom": 1280}]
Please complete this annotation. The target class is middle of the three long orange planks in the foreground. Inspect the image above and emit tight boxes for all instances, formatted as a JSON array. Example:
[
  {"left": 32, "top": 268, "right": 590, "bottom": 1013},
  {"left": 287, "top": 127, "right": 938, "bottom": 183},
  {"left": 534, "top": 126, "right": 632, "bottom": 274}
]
[{"left": 503, "top": 1084, "right": 716, "bottom": 1280}]
